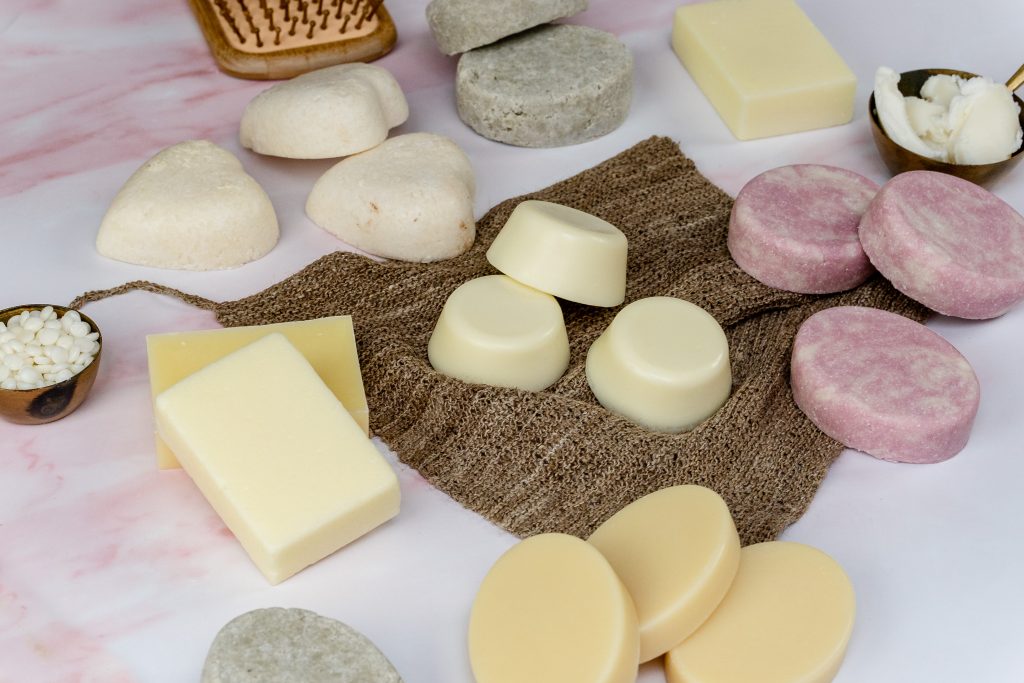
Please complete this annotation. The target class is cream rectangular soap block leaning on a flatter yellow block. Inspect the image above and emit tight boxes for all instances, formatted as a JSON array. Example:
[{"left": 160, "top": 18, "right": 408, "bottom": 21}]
[{"left": 156, "top": 333, "right": 399, "bottom": 584}]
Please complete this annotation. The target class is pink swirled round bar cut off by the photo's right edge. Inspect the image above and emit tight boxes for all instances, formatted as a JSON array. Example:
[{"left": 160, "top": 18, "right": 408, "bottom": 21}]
[{"left": 860, "top": 171, "right": 1024, "bottom": 318}]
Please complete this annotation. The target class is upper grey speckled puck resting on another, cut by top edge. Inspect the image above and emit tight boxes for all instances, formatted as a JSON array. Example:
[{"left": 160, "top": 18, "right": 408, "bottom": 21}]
[{"left": 427, "top": 0, "right": 587, "bottom": 54}]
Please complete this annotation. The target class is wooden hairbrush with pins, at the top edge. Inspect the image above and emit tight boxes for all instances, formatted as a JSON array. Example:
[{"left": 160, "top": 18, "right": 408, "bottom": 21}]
[{"left": 188, "top": 0, "right": 397, "bottom": 79}]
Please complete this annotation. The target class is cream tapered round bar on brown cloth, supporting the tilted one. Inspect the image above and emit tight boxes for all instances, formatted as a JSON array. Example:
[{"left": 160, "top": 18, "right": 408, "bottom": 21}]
[{"left": 427, "top": 275, "right": 569, "bottom": 391}]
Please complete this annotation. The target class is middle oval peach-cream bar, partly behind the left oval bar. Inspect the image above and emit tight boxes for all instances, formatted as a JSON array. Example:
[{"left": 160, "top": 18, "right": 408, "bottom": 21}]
[{"left": 588, "top": 485, "right": 739, "bottom": 661}]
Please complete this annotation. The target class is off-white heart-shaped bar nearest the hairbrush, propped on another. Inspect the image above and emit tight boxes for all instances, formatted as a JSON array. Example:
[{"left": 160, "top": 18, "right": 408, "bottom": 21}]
[{"left": 240, "top": 63, "right": 409, "bottom": 159}]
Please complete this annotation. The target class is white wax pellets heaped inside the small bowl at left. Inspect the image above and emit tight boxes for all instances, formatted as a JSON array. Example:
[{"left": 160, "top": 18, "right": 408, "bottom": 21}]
[{"left": 0, "top": 306, "right": 99, "bottom": 389}]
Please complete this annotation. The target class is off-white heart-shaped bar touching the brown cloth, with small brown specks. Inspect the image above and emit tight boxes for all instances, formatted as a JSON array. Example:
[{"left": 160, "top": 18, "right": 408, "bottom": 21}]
[{"left": 306, "top": 133, "right": 476, "bottom": 262}]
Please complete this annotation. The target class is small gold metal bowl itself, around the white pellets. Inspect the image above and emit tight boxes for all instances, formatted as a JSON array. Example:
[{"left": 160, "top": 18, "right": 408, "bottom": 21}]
[{"left": 0, "top": 303, "right": 103, "bottom": 425}]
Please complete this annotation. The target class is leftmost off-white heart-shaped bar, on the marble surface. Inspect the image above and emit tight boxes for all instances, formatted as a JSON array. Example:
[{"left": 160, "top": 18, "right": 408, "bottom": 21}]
[{"left": 96, "top": 140, "right": 279, "bottom": 270}]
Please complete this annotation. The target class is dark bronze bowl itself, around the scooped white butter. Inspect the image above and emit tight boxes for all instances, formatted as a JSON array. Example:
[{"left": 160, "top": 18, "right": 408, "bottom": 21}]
[{"left": 867, "top": 69, "right": 1024, "bottom": 185}]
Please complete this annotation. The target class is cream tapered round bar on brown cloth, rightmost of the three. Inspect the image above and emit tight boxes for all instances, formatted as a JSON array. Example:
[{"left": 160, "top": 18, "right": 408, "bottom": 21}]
[{"left": 587, "top": 297, "right": 732, "bottom": 433}]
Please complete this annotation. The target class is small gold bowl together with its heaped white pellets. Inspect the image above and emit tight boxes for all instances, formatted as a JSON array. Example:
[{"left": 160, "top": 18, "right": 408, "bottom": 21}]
[{"left": 0, "top": 304, "right": 102, "bottom": 425}]
